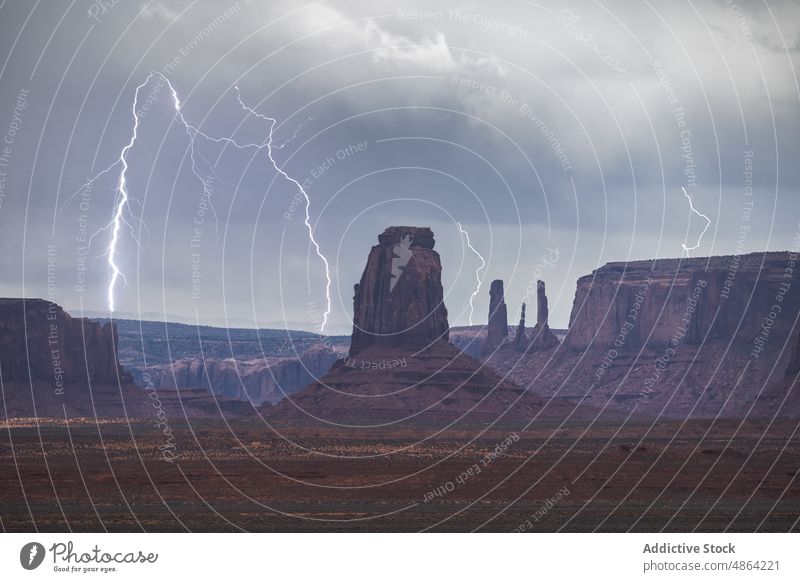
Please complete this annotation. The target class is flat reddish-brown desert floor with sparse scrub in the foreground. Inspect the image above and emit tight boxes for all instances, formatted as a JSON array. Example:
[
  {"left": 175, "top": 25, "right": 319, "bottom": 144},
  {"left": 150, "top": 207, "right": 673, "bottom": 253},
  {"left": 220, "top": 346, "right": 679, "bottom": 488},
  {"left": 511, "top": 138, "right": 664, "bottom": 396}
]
[{"left": 0, "top": 420, "right": 800, "bottom": 532}]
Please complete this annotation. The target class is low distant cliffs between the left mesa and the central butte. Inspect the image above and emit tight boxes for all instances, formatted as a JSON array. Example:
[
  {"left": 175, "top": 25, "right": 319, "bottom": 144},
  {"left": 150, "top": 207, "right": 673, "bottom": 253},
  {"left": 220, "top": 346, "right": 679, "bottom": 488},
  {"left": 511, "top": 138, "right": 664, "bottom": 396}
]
[{"left": 133, "top": 345, "right": 344, "bottom": 406}]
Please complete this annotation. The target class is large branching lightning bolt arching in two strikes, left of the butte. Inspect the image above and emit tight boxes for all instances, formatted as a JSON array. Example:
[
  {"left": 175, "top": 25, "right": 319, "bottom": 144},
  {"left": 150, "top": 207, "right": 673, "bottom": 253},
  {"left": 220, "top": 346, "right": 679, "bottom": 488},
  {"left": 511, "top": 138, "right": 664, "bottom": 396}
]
[{"left": 69, "top": 71, "right": 331, "bottom": 331}]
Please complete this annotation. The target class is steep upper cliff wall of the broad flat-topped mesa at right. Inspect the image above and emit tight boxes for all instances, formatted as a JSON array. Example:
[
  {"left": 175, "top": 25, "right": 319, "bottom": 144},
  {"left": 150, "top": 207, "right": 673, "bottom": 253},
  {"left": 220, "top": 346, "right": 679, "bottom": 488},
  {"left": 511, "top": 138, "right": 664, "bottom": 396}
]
[{"left": 565, "top": 253, "right": 800, "bottom": 349}]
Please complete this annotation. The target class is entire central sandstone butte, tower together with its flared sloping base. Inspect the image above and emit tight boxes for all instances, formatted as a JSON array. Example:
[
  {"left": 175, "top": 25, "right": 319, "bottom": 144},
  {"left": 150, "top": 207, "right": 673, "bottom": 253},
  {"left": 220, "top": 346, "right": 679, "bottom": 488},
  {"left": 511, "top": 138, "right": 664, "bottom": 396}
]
[{"left": 265, "top": 227, "right": 571, "bottom": 430}]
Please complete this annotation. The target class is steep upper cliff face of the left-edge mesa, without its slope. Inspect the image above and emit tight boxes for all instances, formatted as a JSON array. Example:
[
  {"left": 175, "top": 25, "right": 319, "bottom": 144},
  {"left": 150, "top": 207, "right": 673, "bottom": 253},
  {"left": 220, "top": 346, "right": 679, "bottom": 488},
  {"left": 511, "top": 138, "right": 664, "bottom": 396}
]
[{"left": 0, "top": 299, "right": 130, "bottom": 389}]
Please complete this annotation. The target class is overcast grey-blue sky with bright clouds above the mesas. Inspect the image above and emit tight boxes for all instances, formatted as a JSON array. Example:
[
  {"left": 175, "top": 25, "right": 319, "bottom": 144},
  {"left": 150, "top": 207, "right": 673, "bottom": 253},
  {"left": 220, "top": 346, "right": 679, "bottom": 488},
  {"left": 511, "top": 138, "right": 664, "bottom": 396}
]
[{"left": 0, "top": 0, "right": 800, "bottom": 331}]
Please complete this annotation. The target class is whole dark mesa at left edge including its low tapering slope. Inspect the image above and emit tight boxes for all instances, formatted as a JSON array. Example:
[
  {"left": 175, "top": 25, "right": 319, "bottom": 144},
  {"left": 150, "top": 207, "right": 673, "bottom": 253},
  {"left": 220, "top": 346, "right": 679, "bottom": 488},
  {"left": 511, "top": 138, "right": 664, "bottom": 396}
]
[{"left": 0, "top": 299, "right": 254, "bottom": 422}]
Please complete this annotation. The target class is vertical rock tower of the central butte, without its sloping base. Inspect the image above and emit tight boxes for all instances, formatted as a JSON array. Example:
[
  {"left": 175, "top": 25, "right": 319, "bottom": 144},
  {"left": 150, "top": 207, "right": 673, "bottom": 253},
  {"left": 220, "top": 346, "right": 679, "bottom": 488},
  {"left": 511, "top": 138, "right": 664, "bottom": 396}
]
[{"left": 350, "top": 226, "right": 448, "bottom": 356}]
